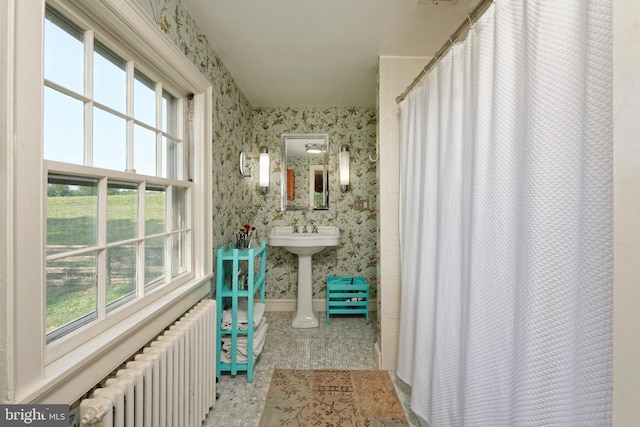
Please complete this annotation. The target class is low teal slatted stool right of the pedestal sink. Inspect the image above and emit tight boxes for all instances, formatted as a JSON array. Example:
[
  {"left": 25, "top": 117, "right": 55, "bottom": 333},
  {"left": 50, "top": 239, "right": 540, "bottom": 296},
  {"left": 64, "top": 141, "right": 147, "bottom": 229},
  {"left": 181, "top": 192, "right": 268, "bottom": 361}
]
[{"left": 326, "top": 276, "right": 369, "bottom": 325}]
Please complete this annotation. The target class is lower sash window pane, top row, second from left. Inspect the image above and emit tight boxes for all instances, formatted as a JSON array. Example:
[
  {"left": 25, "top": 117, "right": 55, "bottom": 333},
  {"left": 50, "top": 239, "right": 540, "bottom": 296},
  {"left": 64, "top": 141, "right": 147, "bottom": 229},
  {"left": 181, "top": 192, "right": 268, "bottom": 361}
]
[{"left": 107, "top": 181, "right": 138, "bottom": 243}]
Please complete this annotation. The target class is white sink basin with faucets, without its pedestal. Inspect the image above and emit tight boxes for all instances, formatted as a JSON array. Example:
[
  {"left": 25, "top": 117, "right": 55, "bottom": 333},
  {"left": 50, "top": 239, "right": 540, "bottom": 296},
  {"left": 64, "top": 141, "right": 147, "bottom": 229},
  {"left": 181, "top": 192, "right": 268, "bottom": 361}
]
[{"left": 269, "top": 225, "right": 340, "bottom": 255}]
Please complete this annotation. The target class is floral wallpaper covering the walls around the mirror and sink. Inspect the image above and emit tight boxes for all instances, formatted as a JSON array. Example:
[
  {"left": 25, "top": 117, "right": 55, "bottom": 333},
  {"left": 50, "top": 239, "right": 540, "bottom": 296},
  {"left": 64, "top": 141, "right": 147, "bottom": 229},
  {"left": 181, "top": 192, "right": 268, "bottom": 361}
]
[{"left": 138, "top": 0, "right": 378, "bottom": 299}]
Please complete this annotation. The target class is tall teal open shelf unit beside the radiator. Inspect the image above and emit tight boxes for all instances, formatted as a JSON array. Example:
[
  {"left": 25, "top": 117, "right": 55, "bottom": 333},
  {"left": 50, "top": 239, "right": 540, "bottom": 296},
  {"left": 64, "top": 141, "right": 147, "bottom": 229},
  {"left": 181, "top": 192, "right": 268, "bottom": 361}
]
[{"left": 216, "top": 240, "right": 267, "bottom": 383}]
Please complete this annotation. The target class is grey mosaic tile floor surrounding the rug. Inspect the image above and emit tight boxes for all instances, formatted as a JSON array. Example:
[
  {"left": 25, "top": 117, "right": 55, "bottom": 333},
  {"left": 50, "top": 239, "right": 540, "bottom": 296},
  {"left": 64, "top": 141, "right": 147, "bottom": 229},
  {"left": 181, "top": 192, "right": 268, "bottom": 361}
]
[{"left": 203, "top": 312, "right": 419, "bottom": 427}]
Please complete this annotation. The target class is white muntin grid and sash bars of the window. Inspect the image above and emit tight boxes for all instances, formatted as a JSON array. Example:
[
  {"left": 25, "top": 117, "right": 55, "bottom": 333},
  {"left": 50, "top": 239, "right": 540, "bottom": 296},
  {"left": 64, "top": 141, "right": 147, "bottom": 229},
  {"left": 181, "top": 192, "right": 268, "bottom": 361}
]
[{"left": 43, "top": 4, "right": 195, "bottom": 348}]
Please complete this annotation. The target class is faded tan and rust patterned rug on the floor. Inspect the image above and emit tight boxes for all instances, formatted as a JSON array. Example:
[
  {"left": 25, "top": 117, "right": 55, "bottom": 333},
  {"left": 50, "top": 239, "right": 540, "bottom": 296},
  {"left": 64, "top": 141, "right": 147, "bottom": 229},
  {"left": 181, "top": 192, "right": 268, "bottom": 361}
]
[{"left": 260, "top": 369, "right": 409, "bottom": 427}]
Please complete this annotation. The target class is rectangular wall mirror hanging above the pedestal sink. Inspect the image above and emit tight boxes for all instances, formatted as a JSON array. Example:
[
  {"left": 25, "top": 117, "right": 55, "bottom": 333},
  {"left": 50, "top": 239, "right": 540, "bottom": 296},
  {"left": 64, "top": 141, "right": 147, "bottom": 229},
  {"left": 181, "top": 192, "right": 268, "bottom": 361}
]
[{"left": 282, "top": 134, "right": 329, "bottom": 211}]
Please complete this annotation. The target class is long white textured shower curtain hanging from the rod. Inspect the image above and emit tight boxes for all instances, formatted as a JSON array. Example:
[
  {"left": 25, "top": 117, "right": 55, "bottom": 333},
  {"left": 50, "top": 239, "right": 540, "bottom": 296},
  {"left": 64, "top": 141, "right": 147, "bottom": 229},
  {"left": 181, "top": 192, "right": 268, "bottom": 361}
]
[{"left": 398, "top": 0, "right": 613, "bottom": 427}]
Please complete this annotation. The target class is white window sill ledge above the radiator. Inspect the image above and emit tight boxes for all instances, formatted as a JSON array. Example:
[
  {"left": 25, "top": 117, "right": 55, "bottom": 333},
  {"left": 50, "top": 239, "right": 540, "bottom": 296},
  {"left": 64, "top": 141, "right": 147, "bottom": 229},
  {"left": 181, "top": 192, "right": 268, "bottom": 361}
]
[{"left": 17, "top": 275, "right": 211, "bottom": 404}]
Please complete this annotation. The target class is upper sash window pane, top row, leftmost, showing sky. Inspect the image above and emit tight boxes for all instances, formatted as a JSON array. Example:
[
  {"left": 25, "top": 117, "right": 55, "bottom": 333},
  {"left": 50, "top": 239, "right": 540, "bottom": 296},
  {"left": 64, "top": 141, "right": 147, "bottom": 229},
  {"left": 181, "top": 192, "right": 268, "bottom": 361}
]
[{"left": 44, "top": 8, "right": 84, "bottom": 95}]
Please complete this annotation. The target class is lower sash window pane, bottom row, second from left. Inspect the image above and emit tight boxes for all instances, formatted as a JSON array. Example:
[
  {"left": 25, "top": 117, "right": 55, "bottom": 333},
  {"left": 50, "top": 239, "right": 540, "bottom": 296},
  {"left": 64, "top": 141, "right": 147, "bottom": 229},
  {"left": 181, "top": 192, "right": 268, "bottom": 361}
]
[{"left": 106, "top": 243, "right": 138, "bottom": 309}]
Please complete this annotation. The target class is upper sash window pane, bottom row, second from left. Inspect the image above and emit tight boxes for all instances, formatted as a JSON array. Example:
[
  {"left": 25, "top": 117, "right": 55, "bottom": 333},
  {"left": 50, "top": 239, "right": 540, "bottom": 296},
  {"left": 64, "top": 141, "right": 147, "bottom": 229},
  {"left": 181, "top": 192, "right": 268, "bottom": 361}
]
[{"left": 93, "top": 108, "right": 127, "bottom": 171}]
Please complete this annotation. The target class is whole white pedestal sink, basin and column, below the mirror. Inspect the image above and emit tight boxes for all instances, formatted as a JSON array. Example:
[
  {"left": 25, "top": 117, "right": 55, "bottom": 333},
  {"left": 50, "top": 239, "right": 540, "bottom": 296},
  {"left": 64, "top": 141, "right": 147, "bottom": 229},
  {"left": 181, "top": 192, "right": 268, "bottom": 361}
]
[{"left": 268, "top": 226, "right": 340, "bottom": 328}]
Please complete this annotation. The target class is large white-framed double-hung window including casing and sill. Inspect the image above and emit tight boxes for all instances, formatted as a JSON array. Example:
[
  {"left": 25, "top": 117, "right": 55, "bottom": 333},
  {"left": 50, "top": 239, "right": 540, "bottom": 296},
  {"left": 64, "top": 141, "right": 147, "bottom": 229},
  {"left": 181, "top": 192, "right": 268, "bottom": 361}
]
[{"left": 0, "top": 0, "right": 212, "bottom": 403}]
